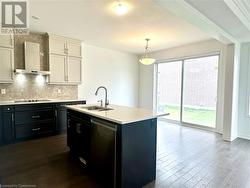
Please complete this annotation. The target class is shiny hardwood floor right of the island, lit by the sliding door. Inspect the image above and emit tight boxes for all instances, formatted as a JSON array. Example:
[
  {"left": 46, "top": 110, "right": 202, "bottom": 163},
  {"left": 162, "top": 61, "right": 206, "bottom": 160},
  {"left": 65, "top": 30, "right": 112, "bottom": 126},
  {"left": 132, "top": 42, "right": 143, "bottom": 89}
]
[{"left": 146, "top": 121, "right": 250, "bottom": 188}]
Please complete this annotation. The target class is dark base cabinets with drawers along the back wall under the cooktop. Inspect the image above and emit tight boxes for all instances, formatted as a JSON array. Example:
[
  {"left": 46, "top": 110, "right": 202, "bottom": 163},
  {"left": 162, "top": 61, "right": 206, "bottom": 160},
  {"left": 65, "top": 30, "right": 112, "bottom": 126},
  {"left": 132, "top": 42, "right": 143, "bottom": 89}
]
[{"left": 0, "top": 101, "right": 86, "bottom": 145}]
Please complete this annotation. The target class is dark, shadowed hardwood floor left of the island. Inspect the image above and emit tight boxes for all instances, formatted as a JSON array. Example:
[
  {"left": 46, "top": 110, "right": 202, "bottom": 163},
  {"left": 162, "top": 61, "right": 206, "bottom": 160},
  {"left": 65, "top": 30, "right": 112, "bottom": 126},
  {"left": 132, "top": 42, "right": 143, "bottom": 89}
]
[{"left": 0, "top": 135, "right": 101, "bottom": 188}]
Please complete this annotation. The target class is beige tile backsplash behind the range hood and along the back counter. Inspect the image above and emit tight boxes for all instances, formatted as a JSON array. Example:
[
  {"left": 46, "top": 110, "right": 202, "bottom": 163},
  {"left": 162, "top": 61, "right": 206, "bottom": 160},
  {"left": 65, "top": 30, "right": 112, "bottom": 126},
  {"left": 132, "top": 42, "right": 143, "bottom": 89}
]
[{"left": 0, "top": 33, "right": 78, "bottom": 101}]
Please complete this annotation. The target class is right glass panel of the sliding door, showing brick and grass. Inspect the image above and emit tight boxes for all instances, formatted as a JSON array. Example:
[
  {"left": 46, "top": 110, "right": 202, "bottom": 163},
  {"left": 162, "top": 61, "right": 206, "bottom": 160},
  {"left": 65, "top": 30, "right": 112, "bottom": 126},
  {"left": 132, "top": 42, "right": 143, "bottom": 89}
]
[{"left": 182, "top": 55, "right": 219, "bottom": 128}]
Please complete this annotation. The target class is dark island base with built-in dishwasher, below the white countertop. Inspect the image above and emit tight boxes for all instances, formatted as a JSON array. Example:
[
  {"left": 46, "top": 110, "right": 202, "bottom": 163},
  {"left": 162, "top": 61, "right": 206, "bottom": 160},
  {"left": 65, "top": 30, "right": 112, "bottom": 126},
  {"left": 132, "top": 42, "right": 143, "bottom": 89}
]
[{"left": 67, "top": 110, "right": 157, "bottom": 188}]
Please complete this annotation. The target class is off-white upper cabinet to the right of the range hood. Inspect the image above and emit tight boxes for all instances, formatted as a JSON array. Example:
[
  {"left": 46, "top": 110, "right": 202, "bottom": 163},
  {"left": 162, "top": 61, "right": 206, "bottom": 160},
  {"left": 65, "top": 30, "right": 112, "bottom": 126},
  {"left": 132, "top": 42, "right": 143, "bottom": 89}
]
[{"left": 48, "top": 34, "right": 82, "bottom": 84}]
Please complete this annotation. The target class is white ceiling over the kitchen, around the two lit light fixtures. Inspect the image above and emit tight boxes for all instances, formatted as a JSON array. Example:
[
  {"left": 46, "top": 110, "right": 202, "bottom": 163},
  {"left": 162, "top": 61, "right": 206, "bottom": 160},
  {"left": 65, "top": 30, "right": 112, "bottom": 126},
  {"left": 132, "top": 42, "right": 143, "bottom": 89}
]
[{"left": 30, "top": 0, "right": 211, "bottom": 53}]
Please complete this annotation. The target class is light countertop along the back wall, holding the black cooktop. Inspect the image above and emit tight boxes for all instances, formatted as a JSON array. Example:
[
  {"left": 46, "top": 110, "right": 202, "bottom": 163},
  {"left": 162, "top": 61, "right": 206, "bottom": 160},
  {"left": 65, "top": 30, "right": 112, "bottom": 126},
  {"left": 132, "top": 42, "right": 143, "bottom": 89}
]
[{"left": 0, "top": 99, "right": 85, "bottom": 106}]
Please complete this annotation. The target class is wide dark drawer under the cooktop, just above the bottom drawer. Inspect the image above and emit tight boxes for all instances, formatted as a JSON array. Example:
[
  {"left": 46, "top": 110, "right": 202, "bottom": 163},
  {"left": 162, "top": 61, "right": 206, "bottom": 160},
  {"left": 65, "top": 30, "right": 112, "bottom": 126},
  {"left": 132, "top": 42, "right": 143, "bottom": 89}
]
[{"left": 15, "top": 110, "right": 55, "bottom": 125}]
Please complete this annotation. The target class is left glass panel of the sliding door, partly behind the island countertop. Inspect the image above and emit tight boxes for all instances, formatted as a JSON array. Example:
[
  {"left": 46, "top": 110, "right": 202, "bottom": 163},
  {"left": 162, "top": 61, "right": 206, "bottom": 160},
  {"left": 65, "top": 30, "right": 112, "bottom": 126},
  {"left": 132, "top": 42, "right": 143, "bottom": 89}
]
[{"left": 157, "top": 61, "right": 182, "bottom": 121}]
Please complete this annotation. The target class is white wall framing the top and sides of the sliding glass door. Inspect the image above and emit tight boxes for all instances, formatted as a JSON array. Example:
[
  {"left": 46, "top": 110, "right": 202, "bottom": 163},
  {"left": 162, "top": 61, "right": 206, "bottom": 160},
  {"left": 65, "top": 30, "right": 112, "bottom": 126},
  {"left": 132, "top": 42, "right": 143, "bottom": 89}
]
[{"left": 139, "top": 40, "right": 229, "bottom": 133}]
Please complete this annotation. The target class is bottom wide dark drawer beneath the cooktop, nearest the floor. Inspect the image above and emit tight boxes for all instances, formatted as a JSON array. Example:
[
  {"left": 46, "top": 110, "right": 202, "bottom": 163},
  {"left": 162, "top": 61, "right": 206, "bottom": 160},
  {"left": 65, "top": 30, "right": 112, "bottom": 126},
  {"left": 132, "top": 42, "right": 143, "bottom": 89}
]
[{"left": 15, "top": 121, "right": 54, "bottom": 139}]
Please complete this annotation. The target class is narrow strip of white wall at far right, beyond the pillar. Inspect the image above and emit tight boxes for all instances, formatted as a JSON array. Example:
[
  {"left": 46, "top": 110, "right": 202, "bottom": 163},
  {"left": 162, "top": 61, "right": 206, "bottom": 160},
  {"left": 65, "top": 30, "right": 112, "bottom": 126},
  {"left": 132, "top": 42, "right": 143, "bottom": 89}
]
[{"left": 238, "top": 43, "right": 250, "bottom": 139}]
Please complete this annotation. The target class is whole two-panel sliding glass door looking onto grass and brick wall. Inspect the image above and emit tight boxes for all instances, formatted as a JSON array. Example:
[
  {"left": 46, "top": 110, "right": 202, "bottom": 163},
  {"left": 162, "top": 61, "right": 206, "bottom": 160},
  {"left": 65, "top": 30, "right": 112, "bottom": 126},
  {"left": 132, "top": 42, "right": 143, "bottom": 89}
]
[{"left": 157, "top": 55, "right": 219, "bottom": 128}]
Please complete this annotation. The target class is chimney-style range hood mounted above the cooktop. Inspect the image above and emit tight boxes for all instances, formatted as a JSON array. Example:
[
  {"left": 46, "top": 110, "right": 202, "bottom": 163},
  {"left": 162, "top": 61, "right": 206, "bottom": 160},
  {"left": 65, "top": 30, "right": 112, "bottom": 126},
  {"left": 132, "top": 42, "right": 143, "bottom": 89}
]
[{"left": 15, "top": 42, "right": 50, "bottom": 75}]
